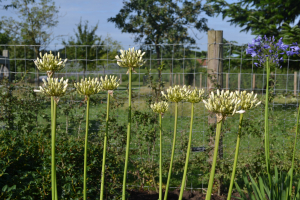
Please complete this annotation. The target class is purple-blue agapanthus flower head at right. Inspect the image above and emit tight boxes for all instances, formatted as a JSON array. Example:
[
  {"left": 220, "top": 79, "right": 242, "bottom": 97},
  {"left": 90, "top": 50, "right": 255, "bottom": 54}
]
[{"left": 246, "top": 36, "right": 300, "bottom": 68}]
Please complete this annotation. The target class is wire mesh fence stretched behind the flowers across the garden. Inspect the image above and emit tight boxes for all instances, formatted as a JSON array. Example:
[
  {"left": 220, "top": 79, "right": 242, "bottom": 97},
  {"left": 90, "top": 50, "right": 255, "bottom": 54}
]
[{"left": 0, "top": 43, "right": 300, "bottom": 190}]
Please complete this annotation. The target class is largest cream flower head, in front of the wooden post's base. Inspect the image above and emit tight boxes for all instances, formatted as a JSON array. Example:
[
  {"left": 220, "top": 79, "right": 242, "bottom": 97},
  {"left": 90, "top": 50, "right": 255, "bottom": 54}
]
[{"left": 203, "top": 90, "right": 244, "bottom": 122}]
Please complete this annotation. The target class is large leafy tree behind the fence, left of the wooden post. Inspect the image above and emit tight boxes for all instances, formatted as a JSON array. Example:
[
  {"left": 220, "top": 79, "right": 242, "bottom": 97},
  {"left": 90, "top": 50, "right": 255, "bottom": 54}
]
[{"left": 108, "top": 0, "right": 211, "bottom": 85}]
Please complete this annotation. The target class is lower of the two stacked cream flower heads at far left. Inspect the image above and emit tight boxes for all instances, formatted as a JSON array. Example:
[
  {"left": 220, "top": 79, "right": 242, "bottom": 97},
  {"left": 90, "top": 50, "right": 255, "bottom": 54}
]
[{"left": 40, "top": 78, "right": 68, "bottom": 97}]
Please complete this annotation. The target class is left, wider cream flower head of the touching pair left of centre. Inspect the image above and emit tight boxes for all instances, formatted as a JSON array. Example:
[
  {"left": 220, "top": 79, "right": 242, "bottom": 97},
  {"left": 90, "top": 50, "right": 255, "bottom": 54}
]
[{"left": 74, "top": 77, "right": 102, "bottom": 96}]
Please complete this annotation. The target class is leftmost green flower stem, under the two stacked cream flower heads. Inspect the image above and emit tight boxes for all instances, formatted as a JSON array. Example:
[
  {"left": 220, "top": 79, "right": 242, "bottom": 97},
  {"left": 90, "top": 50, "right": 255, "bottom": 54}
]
[{"left": 51, "top": 97, "right": 57, "bottom": 200}]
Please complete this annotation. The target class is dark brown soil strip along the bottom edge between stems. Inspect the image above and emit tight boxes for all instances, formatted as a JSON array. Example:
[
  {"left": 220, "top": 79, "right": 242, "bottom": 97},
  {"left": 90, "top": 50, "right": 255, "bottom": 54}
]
[{"left": 128, "top": 190, "right": 248, "bottom": 200}]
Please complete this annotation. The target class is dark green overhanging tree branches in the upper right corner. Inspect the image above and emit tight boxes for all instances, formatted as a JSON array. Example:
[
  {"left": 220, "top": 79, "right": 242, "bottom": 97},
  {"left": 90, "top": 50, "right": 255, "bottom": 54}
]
[{"left": 207, "top": 0, "right": 300, "bottom": 39}]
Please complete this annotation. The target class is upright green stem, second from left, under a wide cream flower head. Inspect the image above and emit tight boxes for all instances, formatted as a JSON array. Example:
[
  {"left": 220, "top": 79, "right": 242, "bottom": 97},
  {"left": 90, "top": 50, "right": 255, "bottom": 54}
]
[{"left": 83, "top": 97, "right": 90, "bottom": 200}]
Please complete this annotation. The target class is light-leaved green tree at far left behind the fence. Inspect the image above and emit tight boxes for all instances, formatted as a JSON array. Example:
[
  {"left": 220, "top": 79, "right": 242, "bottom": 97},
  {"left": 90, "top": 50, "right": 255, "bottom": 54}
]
[{"left": 2, "top": 0, "right": 58, "bottom": 83}]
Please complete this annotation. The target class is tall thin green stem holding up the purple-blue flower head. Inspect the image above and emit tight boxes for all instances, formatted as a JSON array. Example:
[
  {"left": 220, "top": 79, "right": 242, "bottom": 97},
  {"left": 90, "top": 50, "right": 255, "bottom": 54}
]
[{"left": 265, "top": 57, "right": 272, "bottom": 188}]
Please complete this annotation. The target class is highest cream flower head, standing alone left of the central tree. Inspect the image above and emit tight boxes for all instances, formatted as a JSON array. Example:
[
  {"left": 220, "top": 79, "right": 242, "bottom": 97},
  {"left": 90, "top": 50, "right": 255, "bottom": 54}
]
[{"left": 115, "top": 47, "right": 146, "bottom": 70}]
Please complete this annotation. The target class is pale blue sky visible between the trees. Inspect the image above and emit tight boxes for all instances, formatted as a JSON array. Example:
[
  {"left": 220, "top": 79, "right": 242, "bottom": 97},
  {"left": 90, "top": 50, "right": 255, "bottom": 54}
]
[{"left": 0, "top": 0, "right": 254, "bottom": 50}]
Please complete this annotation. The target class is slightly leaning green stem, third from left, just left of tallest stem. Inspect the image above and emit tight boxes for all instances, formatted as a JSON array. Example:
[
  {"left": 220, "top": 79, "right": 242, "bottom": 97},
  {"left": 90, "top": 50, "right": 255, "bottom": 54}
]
[{"left": 100, "top": 92, "right": 110, "bottom": 200}]
